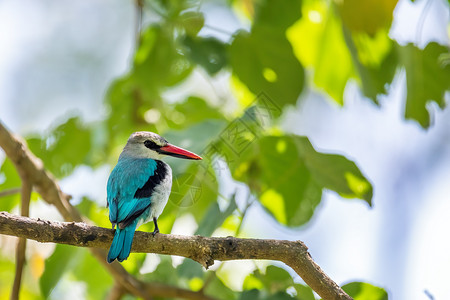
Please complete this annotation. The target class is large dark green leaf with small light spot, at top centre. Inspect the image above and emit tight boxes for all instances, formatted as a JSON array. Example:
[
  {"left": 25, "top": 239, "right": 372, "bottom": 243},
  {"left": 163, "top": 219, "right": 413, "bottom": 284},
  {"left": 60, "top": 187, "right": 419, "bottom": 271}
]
[{"left": 229, "top": 0, "right": 304, "bottom": 105}]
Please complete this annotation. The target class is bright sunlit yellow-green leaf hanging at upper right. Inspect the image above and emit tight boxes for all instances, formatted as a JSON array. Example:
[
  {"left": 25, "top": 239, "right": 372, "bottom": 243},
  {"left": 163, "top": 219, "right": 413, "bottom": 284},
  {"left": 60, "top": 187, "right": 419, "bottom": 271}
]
[{"left": 287, "top": 0, "right": 398, "bottom": 104}]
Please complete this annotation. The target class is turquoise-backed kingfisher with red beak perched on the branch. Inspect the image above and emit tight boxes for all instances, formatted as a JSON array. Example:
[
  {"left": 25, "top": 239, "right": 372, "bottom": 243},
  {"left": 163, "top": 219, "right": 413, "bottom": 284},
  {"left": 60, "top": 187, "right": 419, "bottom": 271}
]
[{"left": 106, "top": 131, "right": 202, "bottom": 263}]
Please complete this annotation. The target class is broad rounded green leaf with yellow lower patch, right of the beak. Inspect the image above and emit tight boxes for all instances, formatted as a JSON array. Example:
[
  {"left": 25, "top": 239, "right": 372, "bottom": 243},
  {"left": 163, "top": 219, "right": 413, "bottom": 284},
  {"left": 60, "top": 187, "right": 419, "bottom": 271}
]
[{"left": 252, "top": 136, "right": 322, "bottom": 226}]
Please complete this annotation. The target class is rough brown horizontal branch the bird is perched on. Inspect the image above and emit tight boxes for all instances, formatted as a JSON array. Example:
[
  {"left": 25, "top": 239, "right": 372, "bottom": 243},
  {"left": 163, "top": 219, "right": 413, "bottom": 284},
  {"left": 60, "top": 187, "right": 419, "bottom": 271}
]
[{"left": 0, "top": 212, "right": 351, "bottom": 299}]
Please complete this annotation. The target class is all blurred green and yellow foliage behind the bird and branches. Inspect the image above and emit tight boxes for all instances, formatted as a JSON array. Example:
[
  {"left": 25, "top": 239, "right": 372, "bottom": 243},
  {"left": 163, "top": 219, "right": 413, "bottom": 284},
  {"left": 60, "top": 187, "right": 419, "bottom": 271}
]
[{"left": 0, "top": 0, "right": 450, "bottom": 300}]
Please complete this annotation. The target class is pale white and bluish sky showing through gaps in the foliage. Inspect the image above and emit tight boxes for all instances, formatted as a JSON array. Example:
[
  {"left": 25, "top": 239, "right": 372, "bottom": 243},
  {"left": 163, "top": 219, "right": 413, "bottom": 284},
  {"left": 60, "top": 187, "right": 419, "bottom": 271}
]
[{"left": 0, "top": 0, "right": 450, "bottom": 300}]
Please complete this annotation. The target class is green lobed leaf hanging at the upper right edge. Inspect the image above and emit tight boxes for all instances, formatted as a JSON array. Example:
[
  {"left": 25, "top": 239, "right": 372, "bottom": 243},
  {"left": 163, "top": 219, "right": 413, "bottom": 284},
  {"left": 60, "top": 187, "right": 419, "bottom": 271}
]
[{"left": 399, "top": 42, "right": 450, "bottom": 128}]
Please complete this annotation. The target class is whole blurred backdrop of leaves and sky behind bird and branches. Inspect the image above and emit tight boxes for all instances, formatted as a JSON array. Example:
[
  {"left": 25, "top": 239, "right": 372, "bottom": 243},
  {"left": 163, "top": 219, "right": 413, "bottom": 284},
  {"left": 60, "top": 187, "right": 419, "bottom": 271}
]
[{"left": 0, "top": 0, "right": 450, "bottom": 299}]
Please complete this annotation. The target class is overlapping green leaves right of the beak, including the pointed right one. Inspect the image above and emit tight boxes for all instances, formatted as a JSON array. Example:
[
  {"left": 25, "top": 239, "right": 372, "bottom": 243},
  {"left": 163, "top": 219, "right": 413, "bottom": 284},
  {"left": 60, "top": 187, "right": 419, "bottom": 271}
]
[{"left": 219, "top": 133, "right": 372, "bottom": 226}]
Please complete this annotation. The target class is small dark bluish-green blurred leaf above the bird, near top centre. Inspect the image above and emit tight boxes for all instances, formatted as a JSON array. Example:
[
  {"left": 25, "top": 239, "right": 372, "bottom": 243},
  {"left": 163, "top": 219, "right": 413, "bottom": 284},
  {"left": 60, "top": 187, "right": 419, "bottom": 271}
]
[{"left": 182, "top": 35, "right": 228, "bottom": 75}]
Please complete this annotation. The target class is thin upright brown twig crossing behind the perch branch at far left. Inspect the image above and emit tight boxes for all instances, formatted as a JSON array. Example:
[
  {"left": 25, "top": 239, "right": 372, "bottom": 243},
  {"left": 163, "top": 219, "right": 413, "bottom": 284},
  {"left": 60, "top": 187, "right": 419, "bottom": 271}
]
[{"left": 11, "top": 171, "right": 32, "bottom": 300}]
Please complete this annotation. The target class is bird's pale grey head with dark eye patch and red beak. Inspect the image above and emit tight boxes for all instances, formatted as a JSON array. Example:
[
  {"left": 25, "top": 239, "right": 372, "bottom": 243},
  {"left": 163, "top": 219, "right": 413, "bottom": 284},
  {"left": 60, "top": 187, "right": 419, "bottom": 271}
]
[{"left": 121, "top": 131, "right": 202, "bottom": 160}]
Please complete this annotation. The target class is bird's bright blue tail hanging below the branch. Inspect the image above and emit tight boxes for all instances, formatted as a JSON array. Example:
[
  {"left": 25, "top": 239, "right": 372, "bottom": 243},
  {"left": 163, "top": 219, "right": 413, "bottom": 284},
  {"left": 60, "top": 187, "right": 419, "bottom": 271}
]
[{"left": 107, "top": 220, "right": 137, "bottom": 263}]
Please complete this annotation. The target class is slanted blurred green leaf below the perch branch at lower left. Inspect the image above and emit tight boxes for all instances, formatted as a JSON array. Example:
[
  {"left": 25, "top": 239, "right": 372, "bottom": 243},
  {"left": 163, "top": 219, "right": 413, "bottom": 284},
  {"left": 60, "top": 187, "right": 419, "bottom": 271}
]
[{"left": 39, "top": 244, "right": 78, "bottom": 298}]
